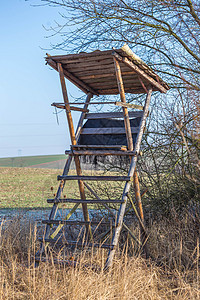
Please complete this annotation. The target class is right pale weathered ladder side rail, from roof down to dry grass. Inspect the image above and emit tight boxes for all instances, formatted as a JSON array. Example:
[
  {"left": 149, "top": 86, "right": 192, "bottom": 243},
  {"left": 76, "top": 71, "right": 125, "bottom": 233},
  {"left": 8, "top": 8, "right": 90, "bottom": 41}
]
[{"left": 105, "top": 86, "right": 152, "bottom": 269}]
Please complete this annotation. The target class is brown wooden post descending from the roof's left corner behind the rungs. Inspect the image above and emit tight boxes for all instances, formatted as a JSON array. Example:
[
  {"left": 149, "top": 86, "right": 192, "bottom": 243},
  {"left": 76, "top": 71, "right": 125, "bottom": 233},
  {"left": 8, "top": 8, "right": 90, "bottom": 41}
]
[{"left": 58, "top": 63, "right": 90, "bottom": 237}]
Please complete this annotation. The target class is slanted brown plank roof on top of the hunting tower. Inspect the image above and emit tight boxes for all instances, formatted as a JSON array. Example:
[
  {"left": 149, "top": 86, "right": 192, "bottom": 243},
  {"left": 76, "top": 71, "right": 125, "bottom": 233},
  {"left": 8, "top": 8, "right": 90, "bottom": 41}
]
[{"left": 46, "top": 45, "right": 169, "bottom": 95}]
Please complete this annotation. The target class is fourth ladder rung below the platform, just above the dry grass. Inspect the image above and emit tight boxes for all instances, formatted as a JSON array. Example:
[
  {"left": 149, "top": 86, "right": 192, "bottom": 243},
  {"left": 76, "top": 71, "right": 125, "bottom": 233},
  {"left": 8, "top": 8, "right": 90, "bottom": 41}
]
[{"left": 38, "top": 238, "right": 114, "bottom": 249}]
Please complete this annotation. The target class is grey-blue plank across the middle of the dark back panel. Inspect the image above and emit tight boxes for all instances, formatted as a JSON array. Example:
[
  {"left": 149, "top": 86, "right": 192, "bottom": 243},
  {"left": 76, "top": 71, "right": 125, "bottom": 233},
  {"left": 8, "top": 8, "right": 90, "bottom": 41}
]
[{"left": 81, "top": 127, "right": 139, "bottom": 134}]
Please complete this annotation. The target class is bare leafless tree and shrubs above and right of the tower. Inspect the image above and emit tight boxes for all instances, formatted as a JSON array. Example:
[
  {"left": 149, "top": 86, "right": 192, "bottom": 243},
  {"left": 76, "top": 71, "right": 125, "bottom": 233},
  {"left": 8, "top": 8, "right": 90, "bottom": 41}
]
[{"left": 41, "top": 0, "right": 200, "bottom": 214}]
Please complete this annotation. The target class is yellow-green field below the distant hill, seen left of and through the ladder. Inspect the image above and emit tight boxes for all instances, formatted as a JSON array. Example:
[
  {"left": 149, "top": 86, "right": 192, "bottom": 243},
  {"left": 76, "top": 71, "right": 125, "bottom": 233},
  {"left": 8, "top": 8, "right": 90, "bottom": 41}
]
[{"left": 0, "top": 167, "right": 123, "bottom": 208}]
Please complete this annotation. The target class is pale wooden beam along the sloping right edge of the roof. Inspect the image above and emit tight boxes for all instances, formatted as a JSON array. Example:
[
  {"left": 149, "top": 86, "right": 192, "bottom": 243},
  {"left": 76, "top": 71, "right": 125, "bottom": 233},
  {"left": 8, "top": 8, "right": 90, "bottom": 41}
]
[{"left": 112, "top": 51, "right": 167, "bottom": 93}]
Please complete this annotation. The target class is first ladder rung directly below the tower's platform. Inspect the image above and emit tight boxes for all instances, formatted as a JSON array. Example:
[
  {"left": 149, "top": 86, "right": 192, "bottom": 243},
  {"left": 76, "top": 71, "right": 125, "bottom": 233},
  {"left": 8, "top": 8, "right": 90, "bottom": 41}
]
[{"left": 57, "top": 175, "right": 131, "bottom": 181}]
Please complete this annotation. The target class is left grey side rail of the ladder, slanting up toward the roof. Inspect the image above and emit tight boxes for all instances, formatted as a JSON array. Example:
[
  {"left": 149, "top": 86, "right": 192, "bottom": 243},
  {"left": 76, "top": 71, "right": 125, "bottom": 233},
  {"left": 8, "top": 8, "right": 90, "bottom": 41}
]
[{"left": 45, "top": 93, "right": 93, "bottom": 239}]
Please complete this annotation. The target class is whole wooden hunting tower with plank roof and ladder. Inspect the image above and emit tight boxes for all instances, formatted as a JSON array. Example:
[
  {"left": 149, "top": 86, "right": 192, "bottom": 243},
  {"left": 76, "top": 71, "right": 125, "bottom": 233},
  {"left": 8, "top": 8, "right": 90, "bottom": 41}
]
[{"left": 37, "top": 45, "right": 169, "bottom": 268}]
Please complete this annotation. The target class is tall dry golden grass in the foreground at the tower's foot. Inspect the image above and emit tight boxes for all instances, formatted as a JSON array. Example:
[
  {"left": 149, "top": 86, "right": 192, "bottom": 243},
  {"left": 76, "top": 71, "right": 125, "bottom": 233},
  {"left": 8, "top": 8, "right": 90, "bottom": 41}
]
[{"left": 0, "top": 219, "right": 200, "bottom": 300}]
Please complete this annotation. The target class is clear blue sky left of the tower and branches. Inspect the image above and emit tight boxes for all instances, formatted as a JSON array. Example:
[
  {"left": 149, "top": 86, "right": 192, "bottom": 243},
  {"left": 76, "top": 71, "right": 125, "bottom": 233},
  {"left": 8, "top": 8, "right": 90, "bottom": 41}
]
[{"left": 0, "top": 0, "right": 80, "bottom": 157}]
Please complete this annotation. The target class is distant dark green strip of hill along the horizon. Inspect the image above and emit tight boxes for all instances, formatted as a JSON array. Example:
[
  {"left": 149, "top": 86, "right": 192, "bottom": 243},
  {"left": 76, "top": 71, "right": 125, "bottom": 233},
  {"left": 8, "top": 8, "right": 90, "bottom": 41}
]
[{"left": 0, "top": 154, "right": 66, "bottom": 168}]
